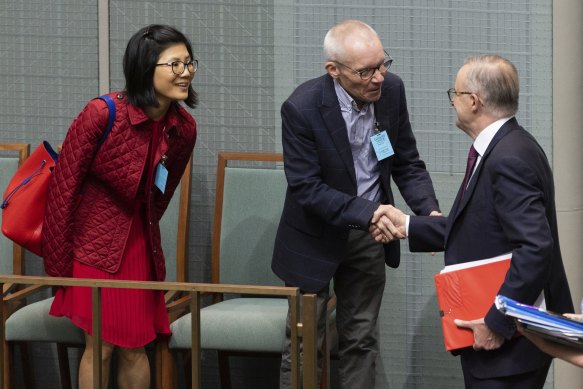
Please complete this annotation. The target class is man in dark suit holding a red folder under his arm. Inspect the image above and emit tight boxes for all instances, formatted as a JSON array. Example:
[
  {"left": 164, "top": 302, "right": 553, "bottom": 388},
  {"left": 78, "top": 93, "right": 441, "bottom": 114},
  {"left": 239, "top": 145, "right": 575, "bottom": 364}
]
[{"left": 373, "top": 55, "right": 573, "bottom": 389}]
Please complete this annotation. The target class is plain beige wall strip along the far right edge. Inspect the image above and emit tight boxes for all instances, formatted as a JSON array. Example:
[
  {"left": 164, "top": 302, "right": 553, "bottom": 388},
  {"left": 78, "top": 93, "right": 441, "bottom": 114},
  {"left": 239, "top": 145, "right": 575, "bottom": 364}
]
[{"left": 553, "top": 0, "right": 583, "bottom": 389}]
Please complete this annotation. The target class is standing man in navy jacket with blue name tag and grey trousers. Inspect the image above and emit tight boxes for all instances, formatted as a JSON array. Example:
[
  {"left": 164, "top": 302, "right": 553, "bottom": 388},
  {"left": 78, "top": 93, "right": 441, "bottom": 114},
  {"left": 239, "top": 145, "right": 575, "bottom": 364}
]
[{"left": 272, "top": 20, "right": 439, "bottom": 389}]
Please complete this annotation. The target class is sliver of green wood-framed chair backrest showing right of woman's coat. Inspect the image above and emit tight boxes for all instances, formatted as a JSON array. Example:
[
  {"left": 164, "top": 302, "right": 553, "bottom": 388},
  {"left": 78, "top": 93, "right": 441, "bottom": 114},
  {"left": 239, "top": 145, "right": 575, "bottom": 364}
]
[{"left": 160, "top": 152, "right": 192, "bottom": 282}]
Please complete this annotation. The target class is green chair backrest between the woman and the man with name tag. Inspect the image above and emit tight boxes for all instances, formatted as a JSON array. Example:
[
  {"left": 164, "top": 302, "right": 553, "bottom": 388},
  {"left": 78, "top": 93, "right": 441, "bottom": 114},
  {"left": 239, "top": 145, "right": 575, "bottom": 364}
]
[{"left": 212, "top": 153, "right": 287, "bottom": 286}]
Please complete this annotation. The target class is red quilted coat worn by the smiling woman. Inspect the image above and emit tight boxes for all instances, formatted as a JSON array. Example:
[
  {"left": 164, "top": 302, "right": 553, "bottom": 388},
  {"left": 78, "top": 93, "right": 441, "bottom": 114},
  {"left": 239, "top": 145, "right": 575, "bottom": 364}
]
[{"left": 42, "top": 93, "right": 196, "bottom": 281}]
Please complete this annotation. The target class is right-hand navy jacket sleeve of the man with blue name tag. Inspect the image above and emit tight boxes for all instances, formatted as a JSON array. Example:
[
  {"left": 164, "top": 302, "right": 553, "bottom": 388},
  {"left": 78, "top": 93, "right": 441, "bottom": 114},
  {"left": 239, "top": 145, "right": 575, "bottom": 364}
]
[{"left": 391, "top": 79, "right": 439, "bottom": 216}]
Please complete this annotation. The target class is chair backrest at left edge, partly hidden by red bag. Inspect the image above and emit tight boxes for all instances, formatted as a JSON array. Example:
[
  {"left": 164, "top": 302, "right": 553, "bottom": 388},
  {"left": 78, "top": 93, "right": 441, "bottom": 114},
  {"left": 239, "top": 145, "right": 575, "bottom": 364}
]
[{"left": 0, "top": 143, "right": 30, "bottom": 274}]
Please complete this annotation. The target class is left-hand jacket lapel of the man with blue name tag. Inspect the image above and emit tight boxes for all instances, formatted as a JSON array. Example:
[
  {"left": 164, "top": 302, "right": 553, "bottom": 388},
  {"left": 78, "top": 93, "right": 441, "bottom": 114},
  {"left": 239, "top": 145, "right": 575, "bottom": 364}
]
[{"left": 320, "top": 75, "right": 356, "bottom": 187}]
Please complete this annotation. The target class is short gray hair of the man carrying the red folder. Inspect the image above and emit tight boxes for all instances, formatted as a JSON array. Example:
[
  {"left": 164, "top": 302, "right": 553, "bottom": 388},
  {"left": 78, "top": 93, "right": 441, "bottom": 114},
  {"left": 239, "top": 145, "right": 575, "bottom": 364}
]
[{"left": 464, "top": 55, "right": 520, "bottom": 118}]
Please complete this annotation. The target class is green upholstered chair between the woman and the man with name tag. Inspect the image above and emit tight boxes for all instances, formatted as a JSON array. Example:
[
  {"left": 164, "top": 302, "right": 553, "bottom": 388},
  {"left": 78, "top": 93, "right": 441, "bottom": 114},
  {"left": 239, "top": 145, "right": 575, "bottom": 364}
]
[{"left": 169, "top": 153, "right": 288, "bottom": 388}]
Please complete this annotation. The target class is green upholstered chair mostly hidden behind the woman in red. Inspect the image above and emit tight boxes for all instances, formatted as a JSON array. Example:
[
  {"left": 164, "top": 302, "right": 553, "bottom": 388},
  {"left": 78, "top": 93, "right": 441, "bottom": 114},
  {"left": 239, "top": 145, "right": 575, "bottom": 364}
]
[{"left": 6, "top": 152, "right": 192, "bottom": 389}]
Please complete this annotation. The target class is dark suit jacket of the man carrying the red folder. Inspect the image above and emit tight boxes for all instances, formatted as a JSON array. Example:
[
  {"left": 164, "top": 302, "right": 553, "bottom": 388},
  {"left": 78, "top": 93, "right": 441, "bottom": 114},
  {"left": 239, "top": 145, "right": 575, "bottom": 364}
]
[{"left": 408, "top": 118, "right": 573, "bottom": 378}]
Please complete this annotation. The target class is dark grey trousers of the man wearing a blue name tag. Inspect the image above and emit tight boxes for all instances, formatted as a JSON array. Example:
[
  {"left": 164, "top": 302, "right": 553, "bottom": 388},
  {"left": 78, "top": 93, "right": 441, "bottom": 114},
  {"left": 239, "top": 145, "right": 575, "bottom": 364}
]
[{"left": 280, "top": 230, "right": 385, "bottom": 389}]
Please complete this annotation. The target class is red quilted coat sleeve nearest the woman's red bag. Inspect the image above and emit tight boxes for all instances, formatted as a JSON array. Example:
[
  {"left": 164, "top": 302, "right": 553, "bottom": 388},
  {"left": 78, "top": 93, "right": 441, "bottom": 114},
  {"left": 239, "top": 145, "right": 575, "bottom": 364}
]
[{"left": 42, "top": 99, "right": 108, "bottom": 277}]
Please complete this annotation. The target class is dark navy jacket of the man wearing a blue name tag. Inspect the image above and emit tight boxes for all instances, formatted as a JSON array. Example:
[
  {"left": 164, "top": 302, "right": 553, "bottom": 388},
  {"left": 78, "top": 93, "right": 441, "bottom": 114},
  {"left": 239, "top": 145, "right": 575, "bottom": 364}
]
[{"left": 272, "top": 73, "right": 439, "bottom": 292}]
